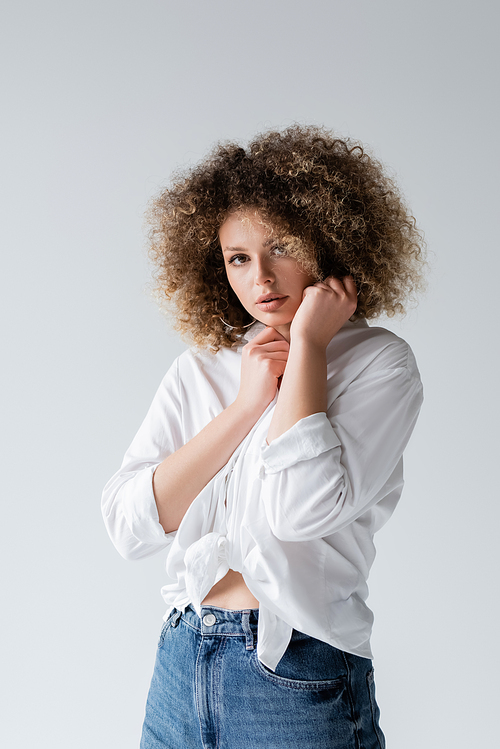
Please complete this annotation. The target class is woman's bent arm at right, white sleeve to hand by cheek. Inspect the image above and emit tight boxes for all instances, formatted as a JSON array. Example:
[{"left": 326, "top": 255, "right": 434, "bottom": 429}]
[{"left": 262, "top": 277, "right": 422, "bottom": 541}]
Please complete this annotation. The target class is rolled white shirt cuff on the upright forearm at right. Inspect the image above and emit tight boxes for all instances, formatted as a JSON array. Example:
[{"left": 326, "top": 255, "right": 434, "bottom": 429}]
[{"left": 261, "top": 411, "right": 340, "bottom": 473}]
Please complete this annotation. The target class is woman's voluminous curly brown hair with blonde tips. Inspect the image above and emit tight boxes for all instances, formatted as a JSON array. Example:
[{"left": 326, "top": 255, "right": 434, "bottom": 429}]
[{"left": 147, "top": 125, "right": 424, "bottom": 350}]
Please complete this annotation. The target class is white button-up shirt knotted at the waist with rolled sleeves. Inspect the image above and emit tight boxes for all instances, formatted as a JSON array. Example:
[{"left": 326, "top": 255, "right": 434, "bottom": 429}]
[{"left": 102, "top": 320, "right": 422, "bottom": 670}]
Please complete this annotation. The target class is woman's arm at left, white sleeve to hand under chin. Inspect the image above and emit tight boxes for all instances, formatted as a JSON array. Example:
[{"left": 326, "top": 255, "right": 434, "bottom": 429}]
[{"left": 102, "top": 328, "right": 289, "bottom": 559}]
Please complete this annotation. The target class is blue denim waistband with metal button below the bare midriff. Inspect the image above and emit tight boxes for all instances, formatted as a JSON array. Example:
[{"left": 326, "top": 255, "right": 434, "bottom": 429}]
[{"left": 174, "top": 605, "right": 259, "bottom": 650}]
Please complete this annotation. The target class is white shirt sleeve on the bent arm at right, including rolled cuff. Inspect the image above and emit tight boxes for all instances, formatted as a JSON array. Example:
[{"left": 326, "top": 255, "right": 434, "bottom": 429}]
[{"left": 260, "top": 341, "right": 422, "bottom": 541}]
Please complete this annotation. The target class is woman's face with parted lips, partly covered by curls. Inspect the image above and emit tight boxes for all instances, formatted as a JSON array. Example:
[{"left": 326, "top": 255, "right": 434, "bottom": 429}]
[{"left": 219, "top": 209, "right": 316, "bottom": 339}]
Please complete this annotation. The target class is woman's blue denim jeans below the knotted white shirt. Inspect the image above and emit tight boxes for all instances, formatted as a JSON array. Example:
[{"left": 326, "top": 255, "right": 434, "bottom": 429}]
[{"left": 141, "top": 606, "right": 385, "bottom": 749}]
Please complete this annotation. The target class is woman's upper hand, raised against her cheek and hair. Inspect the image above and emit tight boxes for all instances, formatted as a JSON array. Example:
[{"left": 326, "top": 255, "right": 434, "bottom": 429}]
[{"left": 290, "top": 276, "right": 358, "bottom": 349}]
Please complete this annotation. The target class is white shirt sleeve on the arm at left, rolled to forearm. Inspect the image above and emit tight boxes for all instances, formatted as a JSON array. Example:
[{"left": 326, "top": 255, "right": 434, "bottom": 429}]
[{"left": 101, "top": 360, "right": 183, "bottom": 559}]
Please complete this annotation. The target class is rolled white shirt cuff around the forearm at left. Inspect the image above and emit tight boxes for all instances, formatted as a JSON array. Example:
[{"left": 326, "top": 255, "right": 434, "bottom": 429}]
[{"left": 122, "top": 463, "right": 177, "bottom": 546}]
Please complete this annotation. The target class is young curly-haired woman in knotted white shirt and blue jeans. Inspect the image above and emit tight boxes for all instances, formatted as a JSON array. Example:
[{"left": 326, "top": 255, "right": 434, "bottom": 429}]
[{"left": 103, "top": 126, "right": 422, "bottom": 749}]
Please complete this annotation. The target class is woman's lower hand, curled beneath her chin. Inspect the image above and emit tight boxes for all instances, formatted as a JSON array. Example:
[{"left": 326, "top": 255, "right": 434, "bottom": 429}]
[{"left": 235, "top": 328, "right": 290, "bottom": 419}]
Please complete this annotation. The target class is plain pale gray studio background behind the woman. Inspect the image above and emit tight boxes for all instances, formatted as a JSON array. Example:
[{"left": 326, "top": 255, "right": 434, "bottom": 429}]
[{"left": 0, "top": 0, "right": 500, "bottom": 749}]
